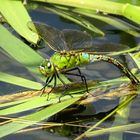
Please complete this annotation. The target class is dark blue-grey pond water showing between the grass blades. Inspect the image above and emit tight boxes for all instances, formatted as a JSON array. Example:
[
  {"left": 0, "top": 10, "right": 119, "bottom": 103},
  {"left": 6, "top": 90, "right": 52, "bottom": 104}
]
[{"left": 0, "top": 4, "right": 140, "bottom": 140}]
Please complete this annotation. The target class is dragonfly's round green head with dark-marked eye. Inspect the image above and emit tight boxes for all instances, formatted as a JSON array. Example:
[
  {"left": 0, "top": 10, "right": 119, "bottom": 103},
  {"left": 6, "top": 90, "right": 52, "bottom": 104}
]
[{"left": 39, "top": 59, "right": 54, "bottom": 76}]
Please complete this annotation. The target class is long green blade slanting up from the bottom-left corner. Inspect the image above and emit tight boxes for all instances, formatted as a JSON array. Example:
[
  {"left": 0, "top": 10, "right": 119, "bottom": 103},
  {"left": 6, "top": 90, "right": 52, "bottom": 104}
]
[{"left": 0, "top": 98, "right": 80, "bottom": 138}]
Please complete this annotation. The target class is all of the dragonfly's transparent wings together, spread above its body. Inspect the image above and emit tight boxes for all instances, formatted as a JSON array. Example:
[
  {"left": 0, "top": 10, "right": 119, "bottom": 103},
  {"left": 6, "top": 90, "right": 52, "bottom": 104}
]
[{"left": 28, "top": 22, "right": 128, "bottom": 54}]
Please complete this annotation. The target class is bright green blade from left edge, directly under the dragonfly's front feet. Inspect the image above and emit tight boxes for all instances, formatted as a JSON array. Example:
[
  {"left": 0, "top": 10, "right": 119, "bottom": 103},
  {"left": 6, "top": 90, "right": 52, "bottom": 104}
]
[{"left": 0, "top": 93, "right": 83, "bottom": 115}]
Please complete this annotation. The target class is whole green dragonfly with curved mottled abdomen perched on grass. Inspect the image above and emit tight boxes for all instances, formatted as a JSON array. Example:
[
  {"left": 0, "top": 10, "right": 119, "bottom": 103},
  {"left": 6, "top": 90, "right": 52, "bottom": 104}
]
[{"left": 29, "top": 22, "right": 139, "bottom": 91}]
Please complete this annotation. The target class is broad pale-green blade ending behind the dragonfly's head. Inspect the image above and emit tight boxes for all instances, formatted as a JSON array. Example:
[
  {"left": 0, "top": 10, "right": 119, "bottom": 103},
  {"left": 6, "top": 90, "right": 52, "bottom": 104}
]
[{"left": 0, "top": 25, "right": 43, "bottom": 76}]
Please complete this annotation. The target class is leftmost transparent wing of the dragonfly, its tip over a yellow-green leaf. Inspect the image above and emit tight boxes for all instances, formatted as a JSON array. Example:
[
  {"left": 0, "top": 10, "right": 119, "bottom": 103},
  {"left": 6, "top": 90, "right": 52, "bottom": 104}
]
[{"left": 28, "top": 22, "right": 67, "bottom": 51}]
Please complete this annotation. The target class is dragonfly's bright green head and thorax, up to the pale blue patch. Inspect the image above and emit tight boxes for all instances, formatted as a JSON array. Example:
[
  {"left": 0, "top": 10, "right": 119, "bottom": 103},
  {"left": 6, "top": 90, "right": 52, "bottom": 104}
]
[{"left": 39, "top": 51, "right": 90, "bottom": 76}]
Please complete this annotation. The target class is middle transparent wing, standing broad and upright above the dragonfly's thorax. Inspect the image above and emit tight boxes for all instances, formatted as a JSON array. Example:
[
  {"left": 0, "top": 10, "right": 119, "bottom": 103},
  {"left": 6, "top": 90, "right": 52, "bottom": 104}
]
[{"left": 62, "top": 29, "right": 92, "bottom": 50}]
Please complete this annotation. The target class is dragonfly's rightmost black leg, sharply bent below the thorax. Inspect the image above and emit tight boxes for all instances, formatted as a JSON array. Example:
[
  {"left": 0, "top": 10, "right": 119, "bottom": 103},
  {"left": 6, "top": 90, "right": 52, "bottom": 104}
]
[{"left": 64, "top": 67, "right": 89, "bottom": 92}]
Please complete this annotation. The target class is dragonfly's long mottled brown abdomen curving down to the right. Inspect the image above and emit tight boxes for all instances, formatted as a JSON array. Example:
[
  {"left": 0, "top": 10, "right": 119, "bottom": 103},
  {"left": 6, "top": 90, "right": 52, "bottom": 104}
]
[{"left": 90, "top": 55, "right": 140, "bottom": 84}]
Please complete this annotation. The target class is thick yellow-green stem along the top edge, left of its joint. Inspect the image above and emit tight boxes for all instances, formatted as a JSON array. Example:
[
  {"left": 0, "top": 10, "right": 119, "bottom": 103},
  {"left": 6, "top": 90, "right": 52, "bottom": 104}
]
[{"left": 32, "top": 0, "right": 124, "bottom": 14}]
